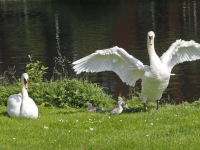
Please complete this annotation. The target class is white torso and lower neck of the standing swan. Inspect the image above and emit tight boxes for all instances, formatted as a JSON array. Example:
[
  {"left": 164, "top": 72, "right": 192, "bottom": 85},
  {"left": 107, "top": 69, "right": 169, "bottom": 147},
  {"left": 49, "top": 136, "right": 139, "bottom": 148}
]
[{"left": 141, "top": 42, "right": 170, "bottom": 103}]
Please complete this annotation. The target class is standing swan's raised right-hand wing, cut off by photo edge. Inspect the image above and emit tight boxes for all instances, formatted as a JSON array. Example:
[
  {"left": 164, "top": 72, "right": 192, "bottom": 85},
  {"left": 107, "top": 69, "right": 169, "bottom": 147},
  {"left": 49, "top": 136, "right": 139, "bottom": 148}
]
[{"left": 160, "top": 40, "right": 200, "bottom": 72}]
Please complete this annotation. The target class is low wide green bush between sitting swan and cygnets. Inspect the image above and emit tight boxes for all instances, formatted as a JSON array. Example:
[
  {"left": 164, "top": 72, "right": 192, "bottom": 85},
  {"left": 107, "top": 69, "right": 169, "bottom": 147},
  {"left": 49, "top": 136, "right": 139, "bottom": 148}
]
[{"left": 29, "top": 79, "right": 114, "bottom": 108}]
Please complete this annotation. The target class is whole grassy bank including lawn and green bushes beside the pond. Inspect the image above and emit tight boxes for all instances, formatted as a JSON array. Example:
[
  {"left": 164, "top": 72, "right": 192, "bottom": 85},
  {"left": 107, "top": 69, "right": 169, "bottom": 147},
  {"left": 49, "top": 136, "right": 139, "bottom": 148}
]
[{"left": 0, "top": 57, "right": 200, "bottom": 150}]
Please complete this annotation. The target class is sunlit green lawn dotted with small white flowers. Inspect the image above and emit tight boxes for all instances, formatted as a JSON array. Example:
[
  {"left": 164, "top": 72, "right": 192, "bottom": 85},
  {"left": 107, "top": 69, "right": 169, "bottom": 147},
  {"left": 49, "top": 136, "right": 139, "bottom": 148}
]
[{"left": 0, "top": 102, "right": 200, "bottom": 150}]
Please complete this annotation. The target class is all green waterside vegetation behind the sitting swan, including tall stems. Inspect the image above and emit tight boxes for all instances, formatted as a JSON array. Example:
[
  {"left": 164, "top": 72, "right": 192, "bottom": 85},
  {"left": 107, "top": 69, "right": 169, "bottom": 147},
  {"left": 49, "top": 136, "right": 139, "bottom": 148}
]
[{"left": 0, "top": 56, "right": 114, "bottom": 108}]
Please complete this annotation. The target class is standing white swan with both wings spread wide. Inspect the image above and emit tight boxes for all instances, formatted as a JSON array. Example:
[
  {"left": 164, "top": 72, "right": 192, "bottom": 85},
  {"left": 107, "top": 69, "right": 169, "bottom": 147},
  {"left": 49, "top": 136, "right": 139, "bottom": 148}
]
[{"left": 73, "top": 31, "right": 200, "bottom": 111}]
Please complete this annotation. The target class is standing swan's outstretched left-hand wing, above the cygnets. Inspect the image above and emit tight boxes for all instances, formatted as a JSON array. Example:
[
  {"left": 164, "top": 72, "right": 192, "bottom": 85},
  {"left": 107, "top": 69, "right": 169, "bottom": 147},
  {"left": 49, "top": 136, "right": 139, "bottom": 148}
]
[{"left": 73, "top": 46, "right": 149, "bottom": 86}]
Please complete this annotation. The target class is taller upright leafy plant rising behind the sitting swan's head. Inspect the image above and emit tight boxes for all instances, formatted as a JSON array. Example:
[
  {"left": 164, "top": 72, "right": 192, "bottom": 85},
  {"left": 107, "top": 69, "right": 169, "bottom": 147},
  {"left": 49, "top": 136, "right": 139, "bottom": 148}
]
[{"left": 25, "top": 55, "right": 48, "bottom": 83}]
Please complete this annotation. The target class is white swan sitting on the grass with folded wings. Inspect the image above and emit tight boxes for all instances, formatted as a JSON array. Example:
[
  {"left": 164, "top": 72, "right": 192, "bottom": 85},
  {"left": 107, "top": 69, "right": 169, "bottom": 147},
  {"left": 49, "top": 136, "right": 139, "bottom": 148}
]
[{"left": 7, "top": 73, "right": 38, "bottom": 119}]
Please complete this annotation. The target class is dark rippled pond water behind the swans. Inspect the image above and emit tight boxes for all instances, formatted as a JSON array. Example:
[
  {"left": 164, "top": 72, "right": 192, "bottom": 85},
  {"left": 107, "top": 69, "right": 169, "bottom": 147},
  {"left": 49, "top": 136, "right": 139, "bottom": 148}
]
[{"left": 0, "top": 0, "right": 200, "bottom": 103}]
